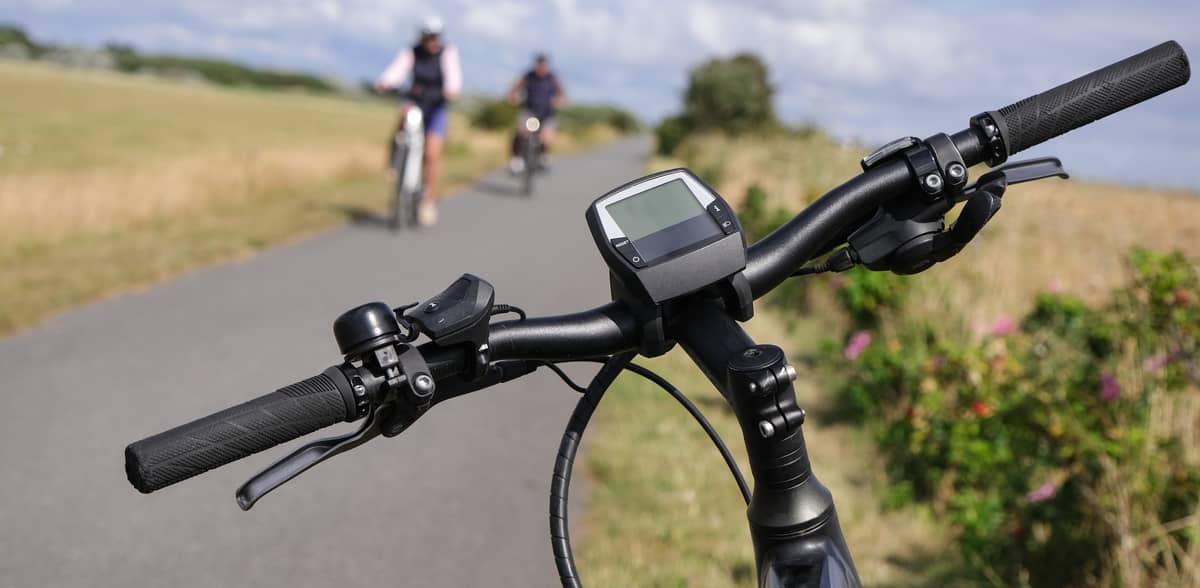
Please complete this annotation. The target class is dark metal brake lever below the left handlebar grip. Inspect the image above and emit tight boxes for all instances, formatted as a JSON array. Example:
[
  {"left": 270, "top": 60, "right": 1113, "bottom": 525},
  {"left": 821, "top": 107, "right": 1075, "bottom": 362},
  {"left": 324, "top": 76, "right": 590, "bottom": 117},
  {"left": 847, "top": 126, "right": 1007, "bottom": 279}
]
[{"left": 235, "top": 402, "right": 395, "bottom": 510}]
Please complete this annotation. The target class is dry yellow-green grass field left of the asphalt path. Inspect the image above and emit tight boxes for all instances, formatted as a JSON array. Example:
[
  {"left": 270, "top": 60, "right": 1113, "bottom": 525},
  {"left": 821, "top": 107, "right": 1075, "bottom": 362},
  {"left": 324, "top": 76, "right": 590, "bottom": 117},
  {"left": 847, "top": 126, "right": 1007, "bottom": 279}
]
[{"left": 0, "top": 61, "right": 612, "bottom": 335}]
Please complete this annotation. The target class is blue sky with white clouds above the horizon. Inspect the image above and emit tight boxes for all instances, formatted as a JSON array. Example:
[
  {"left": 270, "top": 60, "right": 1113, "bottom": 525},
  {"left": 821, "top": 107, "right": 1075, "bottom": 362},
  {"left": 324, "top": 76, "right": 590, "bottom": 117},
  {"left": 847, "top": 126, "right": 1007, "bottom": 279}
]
[{"left": 0, "top": 0, "right": 1200, "bottom": 190}]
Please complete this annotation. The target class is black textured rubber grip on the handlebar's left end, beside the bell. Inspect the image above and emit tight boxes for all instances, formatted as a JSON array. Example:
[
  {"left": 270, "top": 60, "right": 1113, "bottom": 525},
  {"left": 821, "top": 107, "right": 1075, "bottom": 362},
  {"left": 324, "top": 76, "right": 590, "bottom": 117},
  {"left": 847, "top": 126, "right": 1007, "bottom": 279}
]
[{"left": 125, "top": 367, "right": 356, "bottom": 494}]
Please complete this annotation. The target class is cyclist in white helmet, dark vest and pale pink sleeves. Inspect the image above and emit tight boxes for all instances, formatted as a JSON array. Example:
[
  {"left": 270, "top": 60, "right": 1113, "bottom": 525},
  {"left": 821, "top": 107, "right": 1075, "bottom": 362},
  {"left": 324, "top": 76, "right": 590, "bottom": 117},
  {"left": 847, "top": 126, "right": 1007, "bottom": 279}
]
[{"left": 374, "top": 17, "right": 462, "bottom": 226}]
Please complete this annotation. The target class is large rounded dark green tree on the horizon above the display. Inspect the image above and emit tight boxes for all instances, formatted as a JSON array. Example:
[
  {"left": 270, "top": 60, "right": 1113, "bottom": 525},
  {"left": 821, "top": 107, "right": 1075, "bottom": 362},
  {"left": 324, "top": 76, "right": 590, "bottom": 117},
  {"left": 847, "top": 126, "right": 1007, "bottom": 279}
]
[{"left": 683, "top": 53, "right": 779, "bottom": 134}]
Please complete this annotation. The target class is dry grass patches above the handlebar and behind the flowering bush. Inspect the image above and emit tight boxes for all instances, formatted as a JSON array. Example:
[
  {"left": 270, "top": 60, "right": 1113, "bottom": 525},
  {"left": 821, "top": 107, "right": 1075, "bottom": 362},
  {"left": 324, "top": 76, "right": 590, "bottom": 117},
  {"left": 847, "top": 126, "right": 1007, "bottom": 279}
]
[{"left": 676, "top": 133, "right": 1200, "bottom": 328}]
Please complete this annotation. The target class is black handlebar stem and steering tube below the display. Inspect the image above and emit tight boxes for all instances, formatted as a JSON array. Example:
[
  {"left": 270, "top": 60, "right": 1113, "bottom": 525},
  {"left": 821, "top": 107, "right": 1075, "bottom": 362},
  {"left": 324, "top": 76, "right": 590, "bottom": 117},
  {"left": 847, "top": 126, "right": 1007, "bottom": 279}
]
[{"left": 678, "top": 305, "right": 860, "bottom": 588}]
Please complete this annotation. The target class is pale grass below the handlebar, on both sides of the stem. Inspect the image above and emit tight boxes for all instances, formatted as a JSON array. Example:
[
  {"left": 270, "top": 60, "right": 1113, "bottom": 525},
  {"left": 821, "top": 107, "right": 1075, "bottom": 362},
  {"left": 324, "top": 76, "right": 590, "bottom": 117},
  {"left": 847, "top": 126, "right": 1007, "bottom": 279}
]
[{"left": 577, "top": 312, "right": 954, "bottom": 587}]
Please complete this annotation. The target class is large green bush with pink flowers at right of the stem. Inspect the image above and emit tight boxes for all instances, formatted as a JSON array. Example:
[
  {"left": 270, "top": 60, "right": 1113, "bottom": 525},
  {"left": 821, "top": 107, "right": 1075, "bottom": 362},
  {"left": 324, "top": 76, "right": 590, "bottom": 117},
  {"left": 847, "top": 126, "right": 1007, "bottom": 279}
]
[{"left": 839, "top": 251, "right": 1200, "bottom": 587}]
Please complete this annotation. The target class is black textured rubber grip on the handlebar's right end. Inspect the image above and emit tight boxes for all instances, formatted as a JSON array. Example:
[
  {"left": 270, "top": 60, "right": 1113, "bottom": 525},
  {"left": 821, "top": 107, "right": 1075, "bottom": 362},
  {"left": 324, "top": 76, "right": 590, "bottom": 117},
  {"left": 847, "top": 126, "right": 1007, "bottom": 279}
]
[{"left": 997, "top": 41, "right": 1192, "bottom": 155}]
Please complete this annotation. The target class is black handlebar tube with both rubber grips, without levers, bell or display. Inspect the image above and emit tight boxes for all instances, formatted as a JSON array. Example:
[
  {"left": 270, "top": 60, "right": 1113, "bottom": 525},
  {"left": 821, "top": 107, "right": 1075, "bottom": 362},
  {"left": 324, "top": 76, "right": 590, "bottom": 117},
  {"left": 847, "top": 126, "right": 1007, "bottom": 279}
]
[{"left": 125, "top": 41, "right": 1190, "bottom": 493}]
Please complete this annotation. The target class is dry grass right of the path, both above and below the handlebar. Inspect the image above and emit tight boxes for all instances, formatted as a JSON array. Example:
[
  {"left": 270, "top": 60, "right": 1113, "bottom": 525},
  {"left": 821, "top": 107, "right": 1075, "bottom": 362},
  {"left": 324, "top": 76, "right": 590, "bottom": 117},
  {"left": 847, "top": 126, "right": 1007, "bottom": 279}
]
[{"left": 580, "top": 133, "right": 1200, "bottom": 587}]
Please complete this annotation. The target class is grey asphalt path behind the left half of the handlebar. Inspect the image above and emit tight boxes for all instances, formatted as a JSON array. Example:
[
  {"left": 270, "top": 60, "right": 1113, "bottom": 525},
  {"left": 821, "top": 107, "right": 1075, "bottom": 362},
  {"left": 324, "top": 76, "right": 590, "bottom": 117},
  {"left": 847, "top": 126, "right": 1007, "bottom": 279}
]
[{"left": 0, "top": 139, "right": 648, "bottom": 588}]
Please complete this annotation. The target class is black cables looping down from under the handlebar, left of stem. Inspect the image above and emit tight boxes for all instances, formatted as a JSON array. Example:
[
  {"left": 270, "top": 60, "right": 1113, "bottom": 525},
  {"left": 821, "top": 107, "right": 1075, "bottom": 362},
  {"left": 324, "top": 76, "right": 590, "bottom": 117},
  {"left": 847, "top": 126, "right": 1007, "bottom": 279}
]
[{"left": 538, "top": 352, "right": 750, "bottom": 588}]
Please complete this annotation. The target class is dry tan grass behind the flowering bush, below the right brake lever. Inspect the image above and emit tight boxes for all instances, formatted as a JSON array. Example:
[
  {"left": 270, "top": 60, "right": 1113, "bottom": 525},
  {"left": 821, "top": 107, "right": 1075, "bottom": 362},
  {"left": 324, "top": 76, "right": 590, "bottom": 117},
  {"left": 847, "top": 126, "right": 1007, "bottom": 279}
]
[{"left": 917, "top": 180, "right": 1200, "bottom": 330}]
